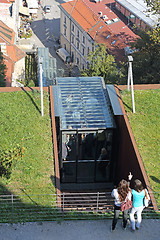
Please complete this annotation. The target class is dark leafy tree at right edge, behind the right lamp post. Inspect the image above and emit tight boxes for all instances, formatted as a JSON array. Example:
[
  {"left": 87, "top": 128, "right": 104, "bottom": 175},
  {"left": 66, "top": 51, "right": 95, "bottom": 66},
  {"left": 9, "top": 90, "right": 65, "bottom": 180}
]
[{"left": 133, "top": 28, "right": 160, "bottom": 83}]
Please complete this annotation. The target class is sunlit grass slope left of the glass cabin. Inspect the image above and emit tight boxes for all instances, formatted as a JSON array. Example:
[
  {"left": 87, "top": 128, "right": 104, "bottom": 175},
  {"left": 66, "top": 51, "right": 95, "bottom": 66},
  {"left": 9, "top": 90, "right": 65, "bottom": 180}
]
[{"left": 0, "top": 90, "right": 55, "bottom": 206}]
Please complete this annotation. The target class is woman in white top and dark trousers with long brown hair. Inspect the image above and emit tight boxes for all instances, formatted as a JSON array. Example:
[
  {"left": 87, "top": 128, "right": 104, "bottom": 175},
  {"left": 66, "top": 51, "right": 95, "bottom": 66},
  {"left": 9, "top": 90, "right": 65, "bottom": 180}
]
[{"left": 111, "top": 179, "right": 132, "bottom": 231}]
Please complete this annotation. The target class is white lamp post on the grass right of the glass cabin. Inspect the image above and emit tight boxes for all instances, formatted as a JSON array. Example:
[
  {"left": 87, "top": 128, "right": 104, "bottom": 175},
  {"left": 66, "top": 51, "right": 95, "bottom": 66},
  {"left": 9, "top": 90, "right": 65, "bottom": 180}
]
[{"left": 127, "top": 56, "right": 135, "bottom": 113}]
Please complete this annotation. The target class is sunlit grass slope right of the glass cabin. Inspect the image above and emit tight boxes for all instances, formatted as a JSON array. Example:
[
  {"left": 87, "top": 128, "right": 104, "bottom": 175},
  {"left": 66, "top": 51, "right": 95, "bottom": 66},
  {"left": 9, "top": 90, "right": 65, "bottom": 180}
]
[{"left": 121, "top": 89, "right": 160, "bottom": 206}]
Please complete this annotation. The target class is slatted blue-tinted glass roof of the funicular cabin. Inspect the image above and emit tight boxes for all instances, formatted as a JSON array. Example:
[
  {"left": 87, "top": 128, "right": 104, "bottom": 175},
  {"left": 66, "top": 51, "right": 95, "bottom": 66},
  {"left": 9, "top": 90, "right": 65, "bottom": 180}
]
[{"left": 53, "top": 77, "right": 115, "bottom": 130}]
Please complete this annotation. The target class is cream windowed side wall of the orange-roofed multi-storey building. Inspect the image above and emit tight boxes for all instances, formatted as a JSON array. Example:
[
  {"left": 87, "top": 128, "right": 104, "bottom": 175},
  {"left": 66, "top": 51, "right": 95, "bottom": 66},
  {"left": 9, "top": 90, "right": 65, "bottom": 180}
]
[{"left": 60, "top": 7, "right": 94, "bottom": 69}]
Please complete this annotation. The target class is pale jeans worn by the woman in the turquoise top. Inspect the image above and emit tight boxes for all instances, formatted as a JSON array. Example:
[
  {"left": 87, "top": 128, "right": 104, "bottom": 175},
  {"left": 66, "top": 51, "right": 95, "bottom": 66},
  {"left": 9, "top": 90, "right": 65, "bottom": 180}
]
[{"left": 129, "top": 206, "right": 144, "bottom": 230}]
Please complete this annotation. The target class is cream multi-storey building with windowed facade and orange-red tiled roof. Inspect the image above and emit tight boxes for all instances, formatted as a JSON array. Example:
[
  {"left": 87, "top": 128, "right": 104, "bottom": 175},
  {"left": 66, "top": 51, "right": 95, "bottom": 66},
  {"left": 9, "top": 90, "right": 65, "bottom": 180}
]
[{"left": 60, "top": 0, "right": 137, "bottom": 69}]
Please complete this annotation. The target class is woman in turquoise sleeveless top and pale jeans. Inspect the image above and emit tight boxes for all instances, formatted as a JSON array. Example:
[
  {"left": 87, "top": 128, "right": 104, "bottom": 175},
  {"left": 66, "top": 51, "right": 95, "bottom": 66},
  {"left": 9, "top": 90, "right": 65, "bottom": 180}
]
[{"left": 129, "top": 179, "right": 150, "bottom": 232}]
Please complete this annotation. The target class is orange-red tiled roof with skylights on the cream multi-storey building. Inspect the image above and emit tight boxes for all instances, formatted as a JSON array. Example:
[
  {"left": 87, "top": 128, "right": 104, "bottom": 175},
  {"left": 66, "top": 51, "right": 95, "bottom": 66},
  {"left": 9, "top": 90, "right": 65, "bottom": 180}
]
[{"left": 61, "top": 0, "right": 138, "bottom": 60}]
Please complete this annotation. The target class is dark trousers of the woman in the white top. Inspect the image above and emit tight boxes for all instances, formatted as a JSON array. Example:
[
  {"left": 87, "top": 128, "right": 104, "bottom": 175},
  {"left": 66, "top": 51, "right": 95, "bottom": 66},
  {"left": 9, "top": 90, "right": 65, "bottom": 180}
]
[{"left": 112, "top": 205, "right": 129, "bottom": 230}]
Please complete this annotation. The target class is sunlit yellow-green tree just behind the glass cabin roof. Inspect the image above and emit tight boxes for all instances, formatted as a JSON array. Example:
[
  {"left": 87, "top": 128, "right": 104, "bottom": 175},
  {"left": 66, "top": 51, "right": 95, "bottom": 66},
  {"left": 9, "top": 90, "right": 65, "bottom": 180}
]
[{"left": 81, "top": 45, "right": 124, "bottom": 84}]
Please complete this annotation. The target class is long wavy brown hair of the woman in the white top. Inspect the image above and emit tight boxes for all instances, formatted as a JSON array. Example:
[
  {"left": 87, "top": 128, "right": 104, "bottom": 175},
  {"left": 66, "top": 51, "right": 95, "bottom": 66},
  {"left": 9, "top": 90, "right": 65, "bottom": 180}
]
[{"left": 117, "top": 179, "right": 130, "bottom": 202}]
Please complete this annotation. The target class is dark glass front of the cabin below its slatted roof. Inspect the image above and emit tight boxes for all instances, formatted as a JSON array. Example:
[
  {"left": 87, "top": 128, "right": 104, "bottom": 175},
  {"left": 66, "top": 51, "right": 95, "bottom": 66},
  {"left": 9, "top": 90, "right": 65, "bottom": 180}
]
[{"left": 60, "top": 129, "right": 113, "bottom": 183}]
